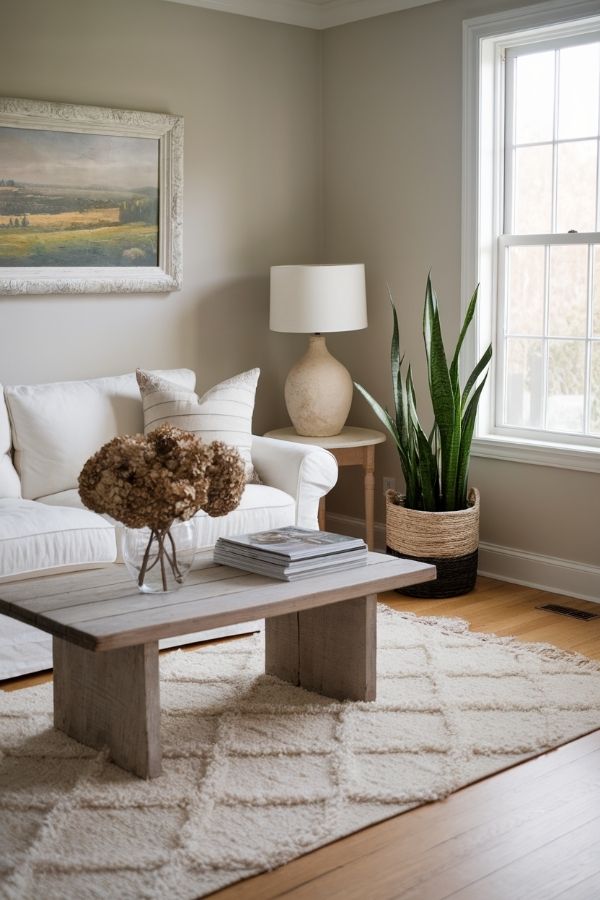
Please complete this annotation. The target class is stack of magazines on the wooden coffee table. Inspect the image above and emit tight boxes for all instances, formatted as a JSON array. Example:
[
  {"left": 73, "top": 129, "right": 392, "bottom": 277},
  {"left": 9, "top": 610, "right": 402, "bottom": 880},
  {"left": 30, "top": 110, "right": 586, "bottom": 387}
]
[{"left": 214, "top": 525, "right": 367, "bottom": 581}]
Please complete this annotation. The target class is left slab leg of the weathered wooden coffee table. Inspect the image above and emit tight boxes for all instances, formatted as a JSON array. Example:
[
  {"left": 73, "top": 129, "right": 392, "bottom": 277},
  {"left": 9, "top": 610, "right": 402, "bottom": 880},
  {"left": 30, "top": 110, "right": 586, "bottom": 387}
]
[{"left": 52, "top": 637, "right": 162, "bottom": 778}]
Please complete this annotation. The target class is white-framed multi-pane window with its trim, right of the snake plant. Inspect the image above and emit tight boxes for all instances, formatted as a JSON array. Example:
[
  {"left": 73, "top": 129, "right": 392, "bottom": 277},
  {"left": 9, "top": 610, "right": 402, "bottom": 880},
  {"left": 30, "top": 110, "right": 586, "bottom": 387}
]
[{"left": 463, "top": 3, "right": 600, "bottom": 471}]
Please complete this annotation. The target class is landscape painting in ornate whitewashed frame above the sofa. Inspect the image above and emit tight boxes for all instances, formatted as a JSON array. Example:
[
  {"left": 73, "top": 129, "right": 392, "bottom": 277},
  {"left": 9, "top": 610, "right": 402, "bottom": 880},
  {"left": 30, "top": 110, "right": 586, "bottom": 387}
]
[{"left": 0, "top": 98, "right": 183, "bottom": 295}]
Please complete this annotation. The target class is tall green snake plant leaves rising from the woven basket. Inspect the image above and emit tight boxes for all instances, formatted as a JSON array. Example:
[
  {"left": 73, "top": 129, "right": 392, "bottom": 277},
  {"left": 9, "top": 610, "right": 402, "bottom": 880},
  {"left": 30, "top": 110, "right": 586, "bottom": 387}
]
[{"left": 355, "top": 276, "right": 492, "bottom": 512}]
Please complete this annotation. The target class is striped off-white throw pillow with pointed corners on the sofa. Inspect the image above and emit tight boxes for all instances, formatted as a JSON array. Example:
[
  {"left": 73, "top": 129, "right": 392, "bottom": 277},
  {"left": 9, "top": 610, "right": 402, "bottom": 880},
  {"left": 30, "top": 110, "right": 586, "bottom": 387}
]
[{"left": 136, "top": 369, "right": 260, "bottom": 479}]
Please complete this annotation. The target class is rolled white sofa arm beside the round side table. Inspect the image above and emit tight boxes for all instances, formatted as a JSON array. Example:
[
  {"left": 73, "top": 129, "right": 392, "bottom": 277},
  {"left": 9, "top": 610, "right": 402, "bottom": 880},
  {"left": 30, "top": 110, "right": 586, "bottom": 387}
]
[{"left": 251, "top": 435, "right": 338, "bottom": 528}]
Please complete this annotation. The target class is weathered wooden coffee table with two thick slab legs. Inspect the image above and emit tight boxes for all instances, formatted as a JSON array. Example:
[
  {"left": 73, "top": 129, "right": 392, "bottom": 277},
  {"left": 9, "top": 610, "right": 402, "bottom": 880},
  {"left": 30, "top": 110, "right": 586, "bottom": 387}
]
[{"left": 0, "top": 553, "right": 435, "bottom": 778}]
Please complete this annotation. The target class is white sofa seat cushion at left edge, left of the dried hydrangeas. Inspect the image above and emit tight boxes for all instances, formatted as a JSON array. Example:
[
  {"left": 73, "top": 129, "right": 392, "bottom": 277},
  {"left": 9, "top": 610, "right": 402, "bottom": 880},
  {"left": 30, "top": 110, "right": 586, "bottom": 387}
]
[{"left": 0, "top": 499, "right": 117, "bottom": 581}]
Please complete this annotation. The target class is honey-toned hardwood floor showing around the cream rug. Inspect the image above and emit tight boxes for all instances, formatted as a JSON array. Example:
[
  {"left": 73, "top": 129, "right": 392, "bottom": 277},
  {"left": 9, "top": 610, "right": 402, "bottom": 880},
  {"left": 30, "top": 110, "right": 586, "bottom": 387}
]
[{"left": 3, "top": 578, "right": 600, "bottom": 900}]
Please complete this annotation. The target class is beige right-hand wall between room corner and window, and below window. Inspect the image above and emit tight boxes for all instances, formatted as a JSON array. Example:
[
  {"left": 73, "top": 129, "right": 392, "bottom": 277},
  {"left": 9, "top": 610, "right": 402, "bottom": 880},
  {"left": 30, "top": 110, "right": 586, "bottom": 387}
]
[{"left": 323, "top": 0, "right": 600, "bottom": 565}]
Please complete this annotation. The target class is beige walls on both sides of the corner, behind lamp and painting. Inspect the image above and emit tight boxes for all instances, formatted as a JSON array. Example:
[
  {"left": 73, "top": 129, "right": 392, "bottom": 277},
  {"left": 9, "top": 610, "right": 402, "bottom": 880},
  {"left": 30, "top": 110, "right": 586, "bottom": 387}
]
[{"left": 0, "top": 0, "right": 600, "bottom": 564}]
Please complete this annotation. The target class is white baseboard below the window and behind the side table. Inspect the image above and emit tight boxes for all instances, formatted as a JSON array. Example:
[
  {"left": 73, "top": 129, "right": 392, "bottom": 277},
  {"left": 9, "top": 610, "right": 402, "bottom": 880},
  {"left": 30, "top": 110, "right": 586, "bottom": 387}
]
[{"left": 327, "top": 513, "right": 600, "bottom": 603}]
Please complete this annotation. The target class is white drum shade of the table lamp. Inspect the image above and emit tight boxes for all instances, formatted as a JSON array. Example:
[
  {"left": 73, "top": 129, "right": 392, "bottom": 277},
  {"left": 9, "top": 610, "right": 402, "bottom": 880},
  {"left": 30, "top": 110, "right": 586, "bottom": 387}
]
[{"left": 269, "top": 263, "right": 367, "bottom": 334}]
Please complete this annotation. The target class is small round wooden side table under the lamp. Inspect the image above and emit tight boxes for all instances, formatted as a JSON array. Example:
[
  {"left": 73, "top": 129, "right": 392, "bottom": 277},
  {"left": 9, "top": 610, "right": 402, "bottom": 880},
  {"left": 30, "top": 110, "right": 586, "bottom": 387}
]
[{"left": 265, "top": 425, "right": 386, "bottom": 550}]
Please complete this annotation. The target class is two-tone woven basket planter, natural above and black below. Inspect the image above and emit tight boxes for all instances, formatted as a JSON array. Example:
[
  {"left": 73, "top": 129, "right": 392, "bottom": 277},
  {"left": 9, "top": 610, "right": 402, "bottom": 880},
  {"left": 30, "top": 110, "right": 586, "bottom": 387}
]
[{"left": 386, "top": 488, "right": 479, "bottom": 599}]
